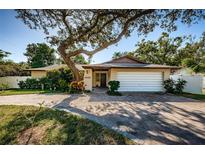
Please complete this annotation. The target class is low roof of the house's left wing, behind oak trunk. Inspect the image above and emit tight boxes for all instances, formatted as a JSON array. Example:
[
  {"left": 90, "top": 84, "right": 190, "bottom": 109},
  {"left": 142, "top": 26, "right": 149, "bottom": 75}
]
[{"left": 26, "top": 64, "right": 84, "bottom": 71}]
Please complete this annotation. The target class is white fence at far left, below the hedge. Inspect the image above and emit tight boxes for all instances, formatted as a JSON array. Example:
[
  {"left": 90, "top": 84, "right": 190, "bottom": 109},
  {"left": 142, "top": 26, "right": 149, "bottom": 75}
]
[{"left": 0, "top": 76, "right": 31, "bottom": 88}]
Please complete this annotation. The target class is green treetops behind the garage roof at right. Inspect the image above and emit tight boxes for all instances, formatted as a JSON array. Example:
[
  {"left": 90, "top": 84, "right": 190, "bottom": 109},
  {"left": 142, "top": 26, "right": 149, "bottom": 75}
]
[{"left": 133, "top": 32, "right": 205, "bottom": 73}]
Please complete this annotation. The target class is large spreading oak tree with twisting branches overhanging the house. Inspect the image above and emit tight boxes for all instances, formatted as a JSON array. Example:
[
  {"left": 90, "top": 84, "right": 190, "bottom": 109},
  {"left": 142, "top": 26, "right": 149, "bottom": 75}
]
[{"left": 16, "top": 9, "right": 205, "bottom": 80}]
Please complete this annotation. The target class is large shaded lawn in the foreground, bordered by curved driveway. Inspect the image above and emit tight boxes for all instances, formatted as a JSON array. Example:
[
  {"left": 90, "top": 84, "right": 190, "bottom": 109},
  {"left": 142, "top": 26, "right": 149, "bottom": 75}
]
[{"left": 0, "top": 105, "right": 134, "bottom": 145}]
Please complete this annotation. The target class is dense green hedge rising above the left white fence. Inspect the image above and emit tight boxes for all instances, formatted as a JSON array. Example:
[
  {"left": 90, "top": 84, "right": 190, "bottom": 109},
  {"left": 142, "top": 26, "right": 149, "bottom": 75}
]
[{"left": 0, "top": 61, "right": 30, "bottom": 77}]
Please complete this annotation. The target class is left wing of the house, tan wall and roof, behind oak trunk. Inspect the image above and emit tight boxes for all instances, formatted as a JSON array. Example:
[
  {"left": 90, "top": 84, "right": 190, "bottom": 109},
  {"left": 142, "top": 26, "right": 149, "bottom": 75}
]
[{"left": 26, "top": 64, "right": 84, "bottom": 78}]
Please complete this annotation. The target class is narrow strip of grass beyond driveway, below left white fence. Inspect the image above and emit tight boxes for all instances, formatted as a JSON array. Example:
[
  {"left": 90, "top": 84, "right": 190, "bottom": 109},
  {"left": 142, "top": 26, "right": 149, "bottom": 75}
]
[{"left": 0, "top": 89, "right": 61, "bottom": 96}]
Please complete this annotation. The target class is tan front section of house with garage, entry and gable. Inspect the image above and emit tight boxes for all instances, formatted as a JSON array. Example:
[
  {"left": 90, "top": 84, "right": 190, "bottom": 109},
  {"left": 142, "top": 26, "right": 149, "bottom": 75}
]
[{"left": 82, "top": 56, "right": 179, "bottom": 92}]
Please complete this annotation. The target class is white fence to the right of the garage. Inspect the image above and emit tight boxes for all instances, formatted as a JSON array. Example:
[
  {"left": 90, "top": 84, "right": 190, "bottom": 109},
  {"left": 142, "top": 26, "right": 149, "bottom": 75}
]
[{"left": 171, "top": 75, "right": 204, "bottom": 94}]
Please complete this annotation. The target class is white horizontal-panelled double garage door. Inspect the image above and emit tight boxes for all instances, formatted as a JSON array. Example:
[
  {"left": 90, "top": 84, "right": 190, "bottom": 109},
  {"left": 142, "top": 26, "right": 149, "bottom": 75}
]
[{"left": 116, "top": 72, "right": 163, "bottom": 92}]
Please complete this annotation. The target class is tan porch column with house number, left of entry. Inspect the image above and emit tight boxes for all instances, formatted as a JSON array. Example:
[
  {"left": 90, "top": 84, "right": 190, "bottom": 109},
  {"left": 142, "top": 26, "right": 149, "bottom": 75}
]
[{"left": 84, "top": 69, "right": 93, "bottom": 91}]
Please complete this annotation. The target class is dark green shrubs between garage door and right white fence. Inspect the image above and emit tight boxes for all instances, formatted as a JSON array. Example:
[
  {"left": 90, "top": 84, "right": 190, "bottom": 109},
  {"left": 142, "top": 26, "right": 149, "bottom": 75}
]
[{"left": 164, "top": 79, "right": 187, "bottom": 94}]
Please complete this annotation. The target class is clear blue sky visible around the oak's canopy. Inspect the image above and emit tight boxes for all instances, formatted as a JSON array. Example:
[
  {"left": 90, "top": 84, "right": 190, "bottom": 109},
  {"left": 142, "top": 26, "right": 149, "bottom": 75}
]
[{"left": 0, "top": 10, "right": 205, "bottom": 63}]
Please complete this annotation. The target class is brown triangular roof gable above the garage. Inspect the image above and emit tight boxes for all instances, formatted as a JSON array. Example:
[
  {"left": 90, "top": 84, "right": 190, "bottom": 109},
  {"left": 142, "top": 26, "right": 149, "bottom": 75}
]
[{"left": 103, "top": 56, "right": 146, "bottom": 64}]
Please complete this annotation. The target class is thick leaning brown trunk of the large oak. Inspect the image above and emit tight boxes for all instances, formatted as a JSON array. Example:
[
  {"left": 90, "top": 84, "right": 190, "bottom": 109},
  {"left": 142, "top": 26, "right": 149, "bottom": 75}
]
[{"left": 58, "top": 44, "right": 81, "bottom": 81}]
